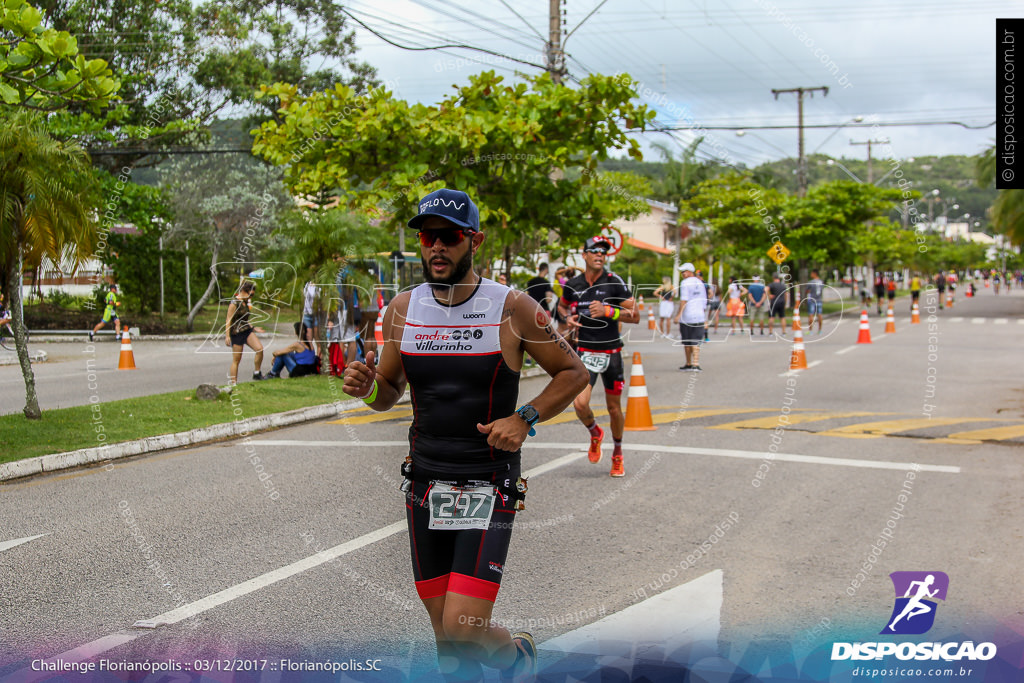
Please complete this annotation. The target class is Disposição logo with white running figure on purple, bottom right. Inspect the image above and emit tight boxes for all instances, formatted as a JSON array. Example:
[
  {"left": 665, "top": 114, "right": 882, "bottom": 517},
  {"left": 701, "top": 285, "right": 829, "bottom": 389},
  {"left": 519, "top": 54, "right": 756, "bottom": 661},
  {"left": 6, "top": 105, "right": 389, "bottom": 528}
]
[{"left": 831, "top": 571, "right": 996, "bottom": 661}]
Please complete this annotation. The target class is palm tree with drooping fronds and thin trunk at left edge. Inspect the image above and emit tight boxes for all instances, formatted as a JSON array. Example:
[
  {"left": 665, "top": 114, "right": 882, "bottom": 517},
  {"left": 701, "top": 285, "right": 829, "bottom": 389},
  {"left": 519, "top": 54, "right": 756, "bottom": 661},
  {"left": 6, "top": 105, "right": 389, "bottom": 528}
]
[{"left": 0, "top": 109, "right": 96, "bottom": 420}]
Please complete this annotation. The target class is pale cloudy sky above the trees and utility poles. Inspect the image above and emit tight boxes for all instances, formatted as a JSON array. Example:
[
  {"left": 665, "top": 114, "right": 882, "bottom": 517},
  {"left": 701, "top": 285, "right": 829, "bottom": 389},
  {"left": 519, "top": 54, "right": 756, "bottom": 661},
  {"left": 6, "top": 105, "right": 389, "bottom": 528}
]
[{"left": 345, "top": 0, "right": 1007, "bottom": 166}]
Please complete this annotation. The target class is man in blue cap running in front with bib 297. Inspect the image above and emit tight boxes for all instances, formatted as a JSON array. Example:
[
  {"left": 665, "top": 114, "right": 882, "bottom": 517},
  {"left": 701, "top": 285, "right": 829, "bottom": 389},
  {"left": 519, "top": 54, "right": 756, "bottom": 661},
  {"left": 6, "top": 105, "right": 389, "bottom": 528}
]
[{"left": 344, "top": 189, "right": 587, "bottom": 681}]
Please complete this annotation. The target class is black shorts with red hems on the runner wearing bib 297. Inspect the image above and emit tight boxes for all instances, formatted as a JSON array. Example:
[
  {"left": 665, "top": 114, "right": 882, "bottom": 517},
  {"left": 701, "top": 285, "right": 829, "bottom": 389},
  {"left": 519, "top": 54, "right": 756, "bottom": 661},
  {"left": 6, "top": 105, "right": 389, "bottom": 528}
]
[{"left": 406, "top": 467, "right": 519, "bottom": 602}]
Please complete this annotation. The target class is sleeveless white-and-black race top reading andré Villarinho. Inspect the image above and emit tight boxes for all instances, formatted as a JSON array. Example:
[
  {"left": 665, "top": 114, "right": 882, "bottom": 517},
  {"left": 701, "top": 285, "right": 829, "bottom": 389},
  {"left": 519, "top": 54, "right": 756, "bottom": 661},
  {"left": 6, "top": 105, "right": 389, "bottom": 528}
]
[{"left": 401, "top": 279, "right": 519, "bottom": 475}]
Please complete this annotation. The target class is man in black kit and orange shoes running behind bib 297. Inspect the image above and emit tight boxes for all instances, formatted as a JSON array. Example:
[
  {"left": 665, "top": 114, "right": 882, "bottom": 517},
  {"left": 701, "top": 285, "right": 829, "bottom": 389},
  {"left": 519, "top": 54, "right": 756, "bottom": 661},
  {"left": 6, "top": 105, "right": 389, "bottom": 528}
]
[{"left": 558, "top": 237, "right": 640, "bottom": 477}]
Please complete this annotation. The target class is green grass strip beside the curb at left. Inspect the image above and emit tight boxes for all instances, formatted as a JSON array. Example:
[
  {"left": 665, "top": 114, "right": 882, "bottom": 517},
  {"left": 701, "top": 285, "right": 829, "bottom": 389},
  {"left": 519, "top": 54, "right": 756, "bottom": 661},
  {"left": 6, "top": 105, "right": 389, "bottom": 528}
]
[{"left": 0, "top": 375, "right": 351, "bottom": 462}]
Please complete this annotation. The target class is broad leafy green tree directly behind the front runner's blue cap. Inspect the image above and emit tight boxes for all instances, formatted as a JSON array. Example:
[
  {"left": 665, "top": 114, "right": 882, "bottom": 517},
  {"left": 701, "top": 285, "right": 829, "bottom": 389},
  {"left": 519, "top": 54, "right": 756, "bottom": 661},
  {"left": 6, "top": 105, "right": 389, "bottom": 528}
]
[{"left": 253, "top": 72, "right": 654, "bottom": 272}]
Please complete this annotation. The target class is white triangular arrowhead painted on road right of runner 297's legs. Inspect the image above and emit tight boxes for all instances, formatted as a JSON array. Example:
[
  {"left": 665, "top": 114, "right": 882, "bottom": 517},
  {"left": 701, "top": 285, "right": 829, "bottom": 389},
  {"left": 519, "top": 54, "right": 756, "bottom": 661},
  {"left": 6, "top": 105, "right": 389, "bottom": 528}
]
[{"left": 538, "top": 569, "right": 724, "bottom": 660}]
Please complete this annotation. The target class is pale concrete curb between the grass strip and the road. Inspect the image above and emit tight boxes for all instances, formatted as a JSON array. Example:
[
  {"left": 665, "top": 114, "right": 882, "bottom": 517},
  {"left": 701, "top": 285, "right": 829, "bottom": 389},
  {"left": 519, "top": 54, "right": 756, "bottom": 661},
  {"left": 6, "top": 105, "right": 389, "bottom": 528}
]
[{"left": 0, "top": 368, "right": 545, "bottom": 482}]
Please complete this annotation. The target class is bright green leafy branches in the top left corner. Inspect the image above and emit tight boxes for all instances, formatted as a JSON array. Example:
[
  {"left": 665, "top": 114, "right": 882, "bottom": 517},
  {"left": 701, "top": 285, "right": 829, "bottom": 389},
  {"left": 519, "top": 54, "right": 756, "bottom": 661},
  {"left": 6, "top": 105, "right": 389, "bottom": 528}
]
[{"left": 0, "top": 0, "right": 120, "bottom": 111}]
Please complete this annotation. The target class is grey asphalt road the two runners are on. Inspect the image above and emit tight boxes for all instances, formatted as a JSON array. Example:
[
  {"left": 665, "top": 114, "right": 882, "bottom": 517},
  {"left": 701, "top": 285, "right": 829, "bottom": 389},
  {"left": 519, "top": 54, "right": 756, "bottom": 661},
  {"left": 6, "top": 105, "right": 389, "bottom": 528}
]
[{"left": 0, "top": 291, "right": 1024, "bottom": 680}]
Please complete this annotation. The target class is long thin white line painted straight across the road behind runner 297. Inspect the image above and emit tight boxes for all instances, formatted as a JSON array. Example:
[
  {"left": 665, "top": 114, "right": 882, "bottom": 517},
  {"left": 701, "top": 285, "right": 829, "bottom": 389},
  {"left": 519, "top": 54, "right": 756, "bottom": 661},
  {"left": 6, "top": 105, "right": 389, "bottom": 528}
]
[{"left": 251, "top": 439, "right": 961, "bottom": 476}]
